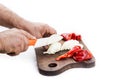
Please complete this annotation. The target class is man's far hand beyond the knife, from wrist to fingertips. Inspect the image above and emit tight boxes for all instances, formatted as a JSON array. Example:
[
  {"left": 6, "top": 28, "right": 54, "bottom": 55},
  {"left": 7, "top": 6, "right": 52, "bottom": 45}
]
[{"left": 24, "top": 23, "right": 56, "bottom": 38}]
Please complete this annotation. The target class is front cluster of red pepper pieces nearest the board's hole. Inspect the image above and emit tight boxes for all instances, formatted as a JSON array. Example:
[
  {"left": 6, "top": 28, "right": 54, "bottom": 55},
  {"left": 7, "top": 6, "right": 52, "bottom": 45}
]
[{"left": 56, "top": 46, "right": 93, "bottom": 62}]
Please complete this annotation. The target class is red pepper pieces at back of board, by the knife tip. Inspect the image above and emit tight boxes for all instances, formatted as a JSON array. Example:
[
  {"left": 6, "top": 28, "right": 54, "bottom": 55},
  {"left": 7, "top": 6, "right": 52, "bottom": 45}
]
[{"left": 61, "top": 33, "right": 81, "bottom": 41}]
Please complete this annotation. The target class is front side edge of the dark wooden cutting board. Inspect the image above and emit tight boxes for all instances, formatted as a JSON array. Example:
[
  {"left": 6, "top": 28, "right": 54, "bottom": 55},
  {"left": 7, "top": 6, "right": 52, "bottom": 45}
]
[{"left": 37, "top": 57, "right": 95, "bottom": 76}]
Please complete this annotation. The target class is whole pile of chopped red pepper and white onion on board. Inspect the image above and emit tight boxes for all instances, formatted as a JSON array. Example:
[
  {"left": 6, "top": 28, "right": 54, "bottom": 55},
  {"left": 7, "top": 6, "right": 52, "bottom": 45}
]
[{"left": 43, "top": 33, "right": 93, "bottom": 62}]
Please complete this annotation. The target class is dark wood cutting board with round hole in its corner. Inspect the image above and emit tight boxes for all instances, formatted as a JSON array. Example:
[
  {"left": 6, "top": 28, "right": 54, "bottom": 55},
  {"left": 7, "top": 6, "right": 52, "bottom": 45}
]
[{"left": 35, "top": 41, "right": 95, "bottom": 76}]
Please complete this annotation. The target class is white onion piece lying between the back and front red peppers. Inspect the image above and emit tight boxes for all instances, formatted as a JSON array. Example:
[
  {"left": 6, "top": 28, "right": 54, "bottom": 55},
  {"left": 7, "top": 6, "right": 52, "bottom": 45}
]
[{"left": 60, "top": 40, "right": 83, "bottom": 50}]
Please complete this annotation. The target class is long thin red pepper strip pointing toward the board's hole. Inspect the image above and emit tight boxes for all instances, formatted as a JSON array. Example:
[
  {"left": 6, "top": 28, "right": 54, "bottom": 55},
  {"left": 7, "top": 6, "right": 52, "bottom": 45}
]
[{"left": 56, "top": 46, "right": 81, "bottom": 60}]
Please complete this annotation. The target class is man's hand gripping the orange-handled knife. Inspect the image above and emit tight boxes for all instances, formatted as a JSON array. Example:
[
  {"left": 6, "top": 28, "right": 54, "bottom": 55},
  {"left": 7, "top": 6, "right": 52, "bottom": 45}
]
[{"left": 0, "top": 28, "right": 35, "bottom": 55}]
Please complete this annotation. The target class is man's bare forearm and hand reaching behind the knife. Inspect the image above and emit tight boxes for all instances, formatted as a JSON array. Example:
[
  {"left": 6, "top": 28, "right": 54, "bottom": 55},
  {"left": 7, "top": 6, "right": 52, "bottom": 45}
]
[{"left": 0, "top": 4, "right": 56, "bottom": 38}]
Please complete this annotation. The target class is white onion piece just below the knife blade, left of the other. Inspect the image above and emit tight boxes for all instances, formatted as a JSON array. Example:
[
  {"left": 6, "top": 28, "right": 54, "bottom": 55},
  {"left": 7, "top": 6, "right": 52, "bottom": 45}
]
[{"left": 43, "top": 42, "right": 61, "bottom": 54}]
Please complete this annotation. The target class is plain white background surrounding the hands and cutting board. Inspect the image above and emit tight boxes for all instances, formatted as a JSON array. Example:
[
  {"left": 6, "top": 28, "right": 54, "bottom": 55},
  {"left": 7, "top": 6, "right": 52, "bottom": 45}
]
[{"left": 0, "top": 0, "right": 120, "bottom": 80}]
